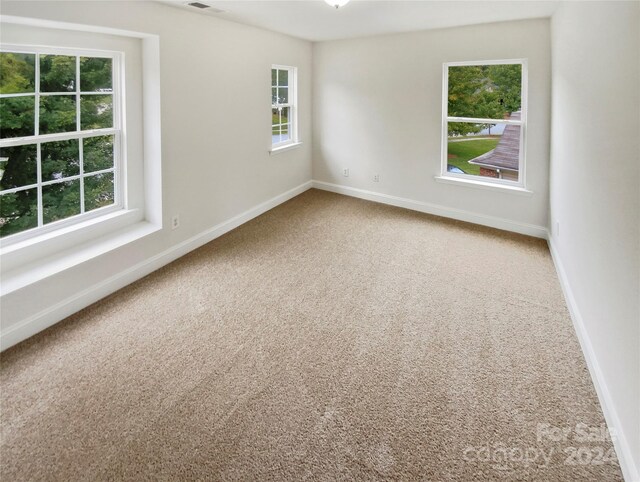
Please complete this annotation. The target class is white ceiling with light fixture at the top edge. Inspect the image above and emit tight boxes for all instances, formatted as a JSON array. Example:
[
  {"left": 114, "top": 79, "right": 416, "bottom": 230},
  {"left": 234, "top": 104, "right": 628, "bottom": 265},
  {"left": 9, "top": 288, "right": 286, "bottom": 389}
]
[{"left": 161, "top": 0, "right": 558, "bottom": 41}]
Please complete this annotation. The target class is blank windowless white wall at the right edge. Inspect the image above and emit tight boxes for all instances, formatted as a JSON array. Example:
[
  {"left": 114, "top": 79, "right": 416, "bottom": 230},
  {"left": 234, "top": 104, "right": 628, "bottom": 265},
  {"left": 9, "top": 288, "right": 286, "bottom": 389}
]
[{"left": 550, "top": 2, "right": 640, "bottom": 480}]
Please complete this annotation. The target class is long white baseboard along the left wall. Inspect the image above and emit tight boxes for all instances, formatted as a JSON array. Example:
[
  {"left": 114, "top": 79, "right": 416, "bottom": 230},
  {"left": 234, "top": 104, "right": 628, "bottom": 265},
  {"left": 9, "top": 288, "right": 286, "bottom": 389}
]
[{"left": 0, "top": 181, "right": 312, "bottom": 350}]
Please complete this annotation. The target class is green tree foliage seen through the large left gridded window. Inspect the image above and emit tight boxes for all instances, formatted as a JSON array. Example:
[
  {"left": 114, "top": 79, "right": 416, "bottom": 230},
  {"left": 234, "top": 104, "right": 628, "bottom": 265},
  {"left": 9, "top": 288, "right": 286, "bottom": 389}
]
[{"left": 0, "top": 53, "right": 114, "bottom": 237}]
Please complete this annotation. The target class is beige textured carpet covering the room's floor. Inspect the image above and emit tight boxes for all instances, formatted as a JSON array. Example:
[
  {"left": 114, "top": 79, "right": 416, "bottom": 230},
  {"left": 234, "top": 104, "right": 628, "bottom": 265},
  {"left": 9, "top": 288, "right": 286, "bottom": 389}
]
[{"left": 0, "top": 190, "right": 621, "bottom": 481}]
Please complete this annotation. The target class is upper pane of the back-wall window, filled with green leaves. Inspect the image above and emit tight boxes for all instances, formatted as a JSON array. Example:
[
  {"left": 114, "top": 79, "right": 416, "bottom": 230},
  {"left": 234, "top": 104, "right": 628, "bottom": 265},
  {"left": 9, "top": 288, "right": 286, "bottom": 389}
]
[{"left": 448, "top": 64, "right": 522, "bottom": 119}]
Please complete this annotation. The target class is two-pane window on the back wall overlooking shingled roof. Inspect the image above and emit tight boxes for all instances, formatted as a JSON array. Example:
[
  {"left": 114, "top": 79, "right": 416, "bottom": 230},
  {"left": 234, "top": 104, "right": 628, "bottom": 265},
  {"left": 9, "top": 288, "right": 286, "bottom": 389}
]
[{"left": 442, "top": 60, "right": 527, "bottom": 186}]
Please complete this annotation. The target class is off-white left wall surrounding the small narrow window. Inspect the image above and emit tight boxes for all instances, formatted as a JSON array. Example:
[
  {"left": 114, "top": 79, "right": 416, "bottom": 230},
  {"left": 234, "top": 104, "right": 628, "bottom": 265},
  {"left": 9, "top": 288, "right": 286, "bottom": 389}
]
[{"left": 1, "top": 1, "right": 312, "bottom": 344}]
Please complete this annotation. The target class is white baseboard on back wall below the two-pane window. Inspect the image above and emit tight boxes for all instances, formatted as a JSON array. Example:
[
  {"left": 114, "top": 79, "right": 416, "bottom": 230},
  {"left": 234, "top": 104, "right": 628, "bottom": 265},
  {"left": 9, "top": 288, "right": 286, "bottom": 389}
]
[{"left": 313, "top": 181, "right": 547, "bottom": 239}]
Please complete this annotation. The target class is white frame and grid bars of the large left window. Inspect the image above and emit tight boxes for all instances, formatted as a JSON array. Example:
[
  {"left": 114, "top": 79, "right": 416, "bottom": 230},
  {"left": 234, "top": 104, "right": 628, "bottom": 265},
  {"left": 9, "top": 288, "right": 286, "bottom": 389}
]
[{"left": 0, "top": 44, "right": 126, "bottom": 248}]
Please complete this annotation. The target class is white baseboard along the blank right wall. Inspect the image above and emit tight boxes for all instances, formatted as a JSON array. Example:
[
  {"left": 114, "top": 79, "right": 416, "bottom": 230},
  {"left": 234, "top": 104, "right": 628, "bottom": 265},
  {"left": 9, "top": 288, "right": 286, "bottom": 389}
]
[{"left": 547, "top": 235, "right": 640, "bottom": 482}]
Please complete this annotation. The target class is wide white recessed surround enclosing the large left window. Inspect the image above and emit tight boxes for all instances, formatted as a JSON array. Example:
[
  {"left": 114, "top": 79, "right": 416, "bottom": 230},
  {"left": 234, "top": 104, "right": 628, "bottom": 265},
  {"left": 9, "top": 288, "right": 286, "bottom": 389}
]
[{"left": 0, "top": 14, "right": 162, "bottom": 302}]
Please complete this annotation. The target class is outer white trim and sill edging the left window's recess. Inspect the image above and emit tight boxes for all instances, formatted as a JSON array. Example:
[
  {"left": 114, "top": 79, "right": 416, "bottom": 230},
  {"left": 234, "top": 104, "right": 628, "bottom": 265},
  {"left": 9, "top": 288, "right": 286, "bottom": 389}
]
[{"left": 0, "top": 15, "right": 163, "bottom": 296}]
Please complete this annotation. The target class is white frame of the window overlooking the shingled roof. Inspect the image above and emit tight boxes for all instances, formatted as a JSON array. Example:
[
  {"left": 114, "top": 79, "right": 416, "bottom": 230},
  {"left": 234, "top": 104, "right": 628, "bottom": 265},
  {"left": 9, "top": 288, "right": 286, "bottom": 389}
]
[{"left": 436, "top": 59, "right": 529, "bottom": 192}]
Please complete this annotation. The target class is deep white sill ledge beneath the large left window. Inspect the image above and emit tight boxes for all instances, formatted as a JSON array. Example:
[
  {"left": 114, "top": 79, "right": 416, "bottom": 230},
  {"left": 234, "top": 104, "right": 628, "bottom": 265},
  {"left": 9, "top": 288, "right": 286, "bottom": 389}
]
[{"left": 0, "top": 215, "right": 162, "bottom": 296}]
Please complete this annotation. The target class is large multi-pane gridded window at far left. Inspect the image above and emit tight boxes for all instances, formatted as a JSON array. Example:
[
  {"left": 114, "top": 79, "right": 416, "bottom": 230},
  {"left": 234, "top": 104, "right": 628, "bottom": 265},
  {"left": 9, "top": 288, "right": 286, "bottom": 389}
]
[{"left": 0, "top": 45, "right": 122, "bottom": 242}]
